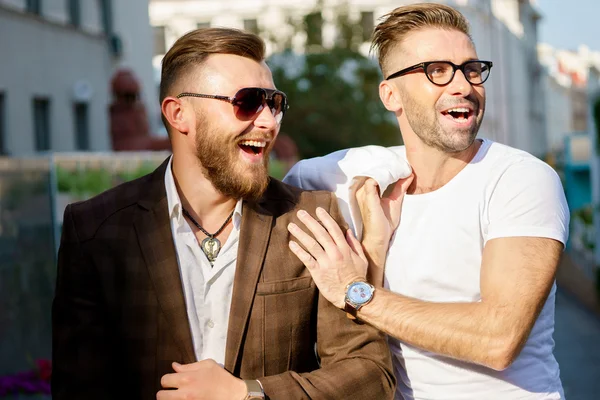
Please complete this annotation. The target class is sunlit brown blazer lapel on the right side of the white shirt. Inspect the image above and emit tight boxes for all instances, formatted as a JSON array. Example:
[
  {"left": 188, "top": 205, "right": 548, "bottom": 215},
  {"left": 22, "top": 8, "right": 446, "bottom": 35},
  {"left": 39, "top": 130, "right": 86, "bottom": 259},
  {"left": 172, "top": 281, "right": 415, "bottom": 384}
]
[{"left": 225, "top": 202, "right": 273, "bottom": 373}]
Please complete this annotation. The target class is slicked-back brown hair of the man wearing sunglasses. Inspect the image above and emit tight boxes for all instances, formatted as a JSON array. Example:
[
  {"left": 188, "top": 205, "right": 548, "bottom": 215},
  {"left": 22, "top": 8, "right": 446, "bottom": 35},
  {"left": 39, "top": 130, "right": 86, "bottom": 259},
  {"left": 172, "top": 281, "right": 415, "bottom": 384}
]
[{"left": 160, "top": 28, "right": 265, "bottom": 130}]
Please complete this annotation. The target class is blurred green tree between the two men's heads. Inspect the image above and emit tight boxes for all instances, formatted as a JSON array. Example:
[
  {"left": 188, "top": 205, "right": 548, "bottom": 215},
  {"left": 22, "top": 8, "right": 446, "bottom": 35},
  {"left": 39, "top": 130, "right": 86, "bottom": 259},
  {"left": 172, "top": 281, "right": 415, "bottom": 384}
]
[{"left": 266, "top": 0, "right": 402, "bottom": 158}]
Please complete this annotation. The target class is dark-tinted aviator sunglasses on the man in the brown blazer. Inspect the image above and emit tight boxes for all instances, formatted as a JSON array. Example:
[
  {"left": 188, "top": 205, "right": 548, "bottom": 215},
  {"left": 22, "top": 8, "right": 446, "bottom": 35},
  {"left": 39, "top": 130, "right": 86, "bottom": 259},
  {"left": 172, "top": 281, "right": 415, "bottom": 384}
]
[{"left": 177, "top": 88, "right": 289, "bottom": 123}]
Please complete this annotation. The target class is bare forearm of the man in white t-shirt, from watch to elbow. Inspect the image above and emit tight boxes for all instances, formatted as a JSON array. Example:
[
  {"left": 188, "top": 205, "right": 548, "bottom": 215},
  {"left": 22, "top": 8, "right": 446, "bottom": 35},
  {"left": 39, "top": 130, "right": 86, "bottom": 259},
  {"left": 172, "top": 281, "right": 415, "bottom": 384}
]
[{"left": 358, "top": 289, "right": 522, "bottom": 369}]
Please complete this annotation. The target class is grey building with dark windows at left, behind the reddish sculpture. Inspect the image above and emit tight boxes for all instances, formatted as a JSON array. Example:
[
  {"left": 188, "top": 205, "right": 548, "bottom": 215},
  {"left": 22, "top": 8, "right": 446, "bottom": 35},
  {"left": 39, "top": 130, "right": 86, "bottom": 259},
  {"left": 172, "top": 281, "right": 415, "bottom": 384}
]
[{"left": 0, "top": 0, "right": 158, "bottom": 156}]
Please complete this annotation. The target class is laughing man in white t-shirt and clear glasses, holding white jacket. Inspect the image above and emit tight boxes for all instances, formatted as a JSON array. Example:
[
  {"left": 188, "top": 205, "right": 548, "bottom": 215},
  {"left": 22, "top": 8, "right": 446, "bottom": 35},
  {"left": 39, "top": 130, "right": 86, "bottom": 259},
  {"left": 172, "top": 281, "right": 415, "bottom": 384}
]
[{"left": 285, "top": 3, "right": 569, "bottom": 400}]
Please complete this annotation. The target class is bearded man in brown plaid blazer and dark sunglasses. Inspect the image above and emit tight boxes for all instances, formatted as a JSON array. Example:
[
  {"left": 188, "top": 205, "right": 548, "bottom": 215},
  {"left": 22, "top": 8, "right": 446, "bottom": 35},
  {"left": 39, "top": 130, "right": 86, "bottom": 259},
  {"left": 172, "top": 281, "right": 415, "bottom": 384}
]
[{"left": 52, "top": 28, "right": 395, "bottom": 400}]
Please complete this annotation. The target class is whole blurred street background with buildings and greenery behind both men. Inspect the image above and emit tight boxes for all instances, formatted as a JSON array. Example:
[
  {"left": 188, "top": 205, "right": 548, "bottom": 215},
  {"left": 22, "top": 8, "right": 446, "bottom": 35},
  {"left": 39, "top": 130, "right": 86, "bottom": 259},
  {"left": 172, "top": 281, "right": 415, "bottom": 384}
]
[{"left": 0, "top": 0, "right": 600, "bottom": 400}]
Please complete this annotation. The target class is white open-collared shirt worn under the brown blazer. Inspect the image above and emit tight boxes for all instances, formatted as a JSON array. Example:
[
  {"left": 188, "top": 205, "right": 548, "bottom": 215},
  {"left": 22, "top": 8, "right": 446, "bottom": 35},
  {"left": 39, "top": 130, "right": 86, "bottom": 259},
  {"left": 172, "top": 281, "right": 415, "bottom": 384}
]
[{"left": 165, "top": 158, "right": 242, "bottom": 365}]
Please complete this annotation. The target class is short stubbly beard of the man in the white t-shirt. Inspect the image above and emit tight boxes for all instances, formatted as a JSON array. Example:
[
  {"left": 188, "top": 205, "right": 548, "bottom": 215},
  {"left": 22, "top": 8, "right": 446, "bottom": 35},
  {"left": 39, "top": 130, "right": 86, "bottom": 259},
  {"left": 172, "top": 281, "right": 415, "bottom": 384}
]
[{"left": 403, "top": 91, "right": 485, "bottom": 153}]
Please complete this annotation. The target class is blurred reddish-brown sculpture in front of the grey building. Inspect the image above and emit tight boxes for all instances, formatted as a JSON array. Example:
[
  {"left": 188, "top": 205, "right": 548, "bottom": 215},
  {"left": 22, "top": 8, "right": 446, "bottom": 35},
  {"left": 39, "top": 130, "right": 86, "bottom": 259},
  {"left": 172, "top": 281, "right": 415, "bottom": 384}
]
[{"left": 109, "top": 69, "right": 171, "bottom": 151}]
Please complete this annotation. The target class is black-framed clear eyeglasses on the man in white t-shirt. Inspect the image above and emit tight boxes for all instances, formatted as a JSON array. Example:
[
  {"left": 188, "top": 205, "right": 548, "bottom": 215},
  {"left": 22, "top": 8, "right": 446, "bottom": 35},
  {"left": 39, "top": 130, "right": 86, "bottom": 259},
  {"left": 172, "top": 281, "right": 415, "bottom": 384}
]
[{"left": 386, "top": 60, "right": 493, "bottom": 86}]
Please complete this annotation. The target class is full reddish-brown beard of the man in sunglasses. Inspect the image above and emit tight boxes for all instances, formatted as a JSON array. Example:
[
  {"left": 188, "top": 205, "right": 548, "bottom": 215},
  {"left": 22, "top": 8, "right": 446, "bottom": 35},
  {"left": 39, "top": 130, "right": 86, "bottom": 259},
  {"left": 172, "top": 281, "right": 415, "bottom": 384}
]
[{"left": 196, "top": 118, "right": 272, "bottom": 201}]
